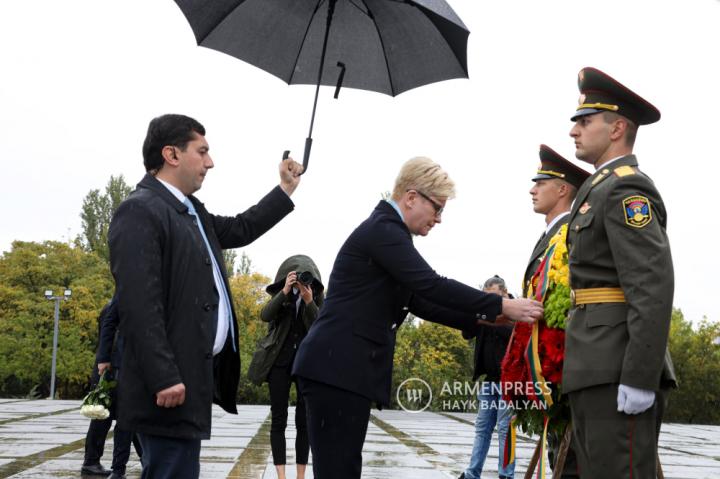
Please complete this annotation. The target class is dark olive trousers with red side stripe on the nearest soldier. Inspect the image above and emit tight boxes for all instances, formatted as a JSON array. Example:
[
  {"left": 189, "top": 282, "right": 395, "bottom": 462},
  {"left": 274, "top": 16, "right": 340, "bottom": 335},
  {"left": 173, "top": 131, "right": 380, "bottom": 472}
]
[{"left": 570, "top": 384, "right": 667, "bottom": 479}]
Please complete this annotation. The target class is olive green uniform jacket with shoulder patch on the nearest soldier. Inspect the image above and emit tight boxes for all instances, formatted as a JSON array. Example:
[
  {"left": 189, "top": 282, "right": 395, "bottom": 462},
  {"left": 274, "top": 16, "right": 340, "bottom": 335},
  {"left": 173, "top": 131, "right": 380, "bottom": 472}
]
[{"left": 563, "top": 155, "right": 675, "bottom": 393}]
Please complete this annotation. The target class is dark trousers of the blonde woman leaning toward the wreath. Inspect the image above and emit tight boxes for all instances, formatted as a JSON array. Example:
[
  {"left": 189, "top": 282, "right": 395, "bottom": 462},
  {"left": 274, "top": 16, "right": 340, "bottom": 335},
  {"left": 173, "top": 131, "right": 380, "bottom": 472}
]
[{"left": 298, "top": 377, "right": 370, "bottom": 479}]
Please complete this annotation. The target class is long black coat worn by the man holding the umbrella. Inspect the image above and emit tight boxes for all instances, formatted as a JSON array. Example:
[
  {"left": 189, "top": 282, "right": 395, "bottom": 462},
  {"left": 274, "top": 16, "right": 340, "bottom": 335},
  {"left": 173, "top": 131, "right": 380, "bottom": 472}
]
[{"left": 108, "top": 175, "right": 293, "bottom": 439}]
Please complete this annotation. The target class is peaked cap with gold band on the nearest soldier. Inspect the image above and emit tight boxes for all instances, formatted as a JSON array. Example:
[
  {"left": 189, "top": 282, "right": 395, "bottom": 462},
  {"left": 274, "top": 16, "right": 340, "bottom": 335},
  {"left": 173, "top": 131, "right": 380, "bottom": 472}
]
[{"left": 571, "top": 67, "right": 660, "bottom": 125}]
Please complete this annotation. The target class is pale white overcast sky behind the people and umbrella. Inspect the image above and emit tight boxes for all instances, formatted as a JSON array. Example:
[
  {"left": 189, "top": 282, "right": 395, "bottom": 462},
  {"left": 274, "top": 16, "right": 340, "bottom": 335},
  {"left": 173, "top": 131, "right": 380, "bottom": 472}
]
[{"left": 0, "top": 0, "right": 720, "bottom": 320}]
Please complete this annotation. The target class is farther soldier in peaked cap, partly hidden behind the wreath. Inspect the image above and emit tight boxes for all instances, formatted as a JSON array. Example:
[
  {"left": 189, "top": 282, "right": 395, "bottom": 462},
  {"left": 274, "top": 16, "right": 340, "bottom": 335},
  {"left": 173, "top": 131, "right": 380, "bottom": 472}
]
[{"left": 523, "top": 145, "right": 590, "bottom": 479}]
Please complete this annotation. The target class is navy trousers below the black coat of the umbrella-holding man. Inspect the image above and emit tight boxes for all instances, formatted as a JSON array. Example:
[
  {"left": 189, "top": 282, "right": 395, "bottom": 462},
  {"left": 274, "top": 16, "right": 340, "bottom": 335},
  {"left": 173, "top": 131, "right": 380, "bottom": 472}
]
[{"left": 138, "top": 433, "right": 200, "bottom": 479}]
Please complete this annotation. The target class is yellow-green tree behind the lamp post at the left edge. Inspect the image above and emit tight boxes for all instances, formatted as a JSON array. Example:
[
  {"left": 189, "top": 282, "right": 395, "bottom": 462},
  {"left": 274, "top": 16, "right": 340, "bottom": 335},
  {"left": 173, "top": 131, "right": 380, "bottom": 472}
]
[{"left": 0, "top": 241, "right": 113, "bottom": 398}]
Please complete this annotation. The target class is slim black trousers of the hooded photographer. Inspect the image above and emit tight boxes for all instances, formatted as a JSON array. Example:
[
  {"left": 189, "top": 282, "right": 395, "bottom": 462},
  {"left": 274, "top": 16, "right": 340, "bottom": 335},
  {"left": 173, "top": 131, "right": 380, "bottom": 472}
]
[{"left": 268, "top": 365, "right": 310, "bottom": 466}]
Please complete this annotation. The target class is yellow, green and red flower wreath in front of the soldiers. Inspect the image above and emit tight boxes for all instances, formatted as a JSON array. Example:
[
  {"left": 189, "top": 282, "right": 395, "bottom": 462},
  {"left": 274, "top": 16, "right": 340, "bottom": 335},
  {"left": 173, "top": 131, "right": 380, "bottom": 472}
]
[{"left": 501, "top": 225, "right": 571, "bottom": 435}]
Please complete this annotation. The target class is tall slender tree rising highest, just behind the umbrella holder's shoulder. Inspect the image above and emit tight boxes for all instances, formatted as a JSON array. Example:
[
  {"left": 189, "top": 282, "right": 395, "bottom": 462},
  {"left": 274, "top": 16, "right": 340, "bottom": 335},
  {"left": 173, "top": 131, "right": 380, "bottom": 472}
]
[{"left": 80, "top": 175, "right": 132, "bottom": 262}]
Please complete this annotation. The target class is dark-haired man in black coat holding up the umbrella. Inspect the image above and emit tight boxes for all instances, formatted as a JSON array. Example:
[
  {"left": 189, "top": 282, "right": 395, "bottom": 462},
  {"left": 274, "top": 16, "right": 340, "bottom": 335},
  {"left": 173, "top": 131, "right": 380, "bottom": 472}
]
[{"left": 108, "top": 115, "right": 302, "bottom": 479}]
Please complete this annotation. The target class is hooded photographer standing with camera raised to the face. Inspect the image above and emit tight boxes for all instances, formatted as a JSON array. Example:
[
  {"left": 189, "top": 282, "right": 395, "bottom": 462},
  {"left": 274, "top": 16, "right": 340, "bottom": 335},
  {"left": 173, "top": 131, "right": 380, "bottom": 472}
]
[{"left": 248, "top": 255, "right": 325, "bottom": 479}]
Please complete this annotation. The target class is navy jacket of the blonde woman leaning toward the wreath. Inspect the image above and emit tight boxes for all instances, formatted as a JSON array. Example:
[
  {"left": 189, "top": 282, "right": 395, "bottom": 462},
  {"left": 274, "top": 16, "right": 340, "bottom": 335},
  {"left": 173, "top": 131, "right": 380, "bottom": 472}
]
[{"left": 293, "top": 201, "right": 502, "bottom": 405}]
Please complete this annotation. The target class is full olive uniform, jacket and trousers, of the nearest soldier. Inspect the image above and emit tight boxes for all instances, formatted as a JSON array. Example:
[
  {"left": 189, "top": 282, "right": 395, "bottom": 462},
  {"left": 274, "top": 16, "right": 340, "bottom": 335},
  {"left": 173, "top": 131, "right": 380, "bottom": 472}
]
[{"left": 563, "top": 155, "right": 675, "bottom": 479}]
